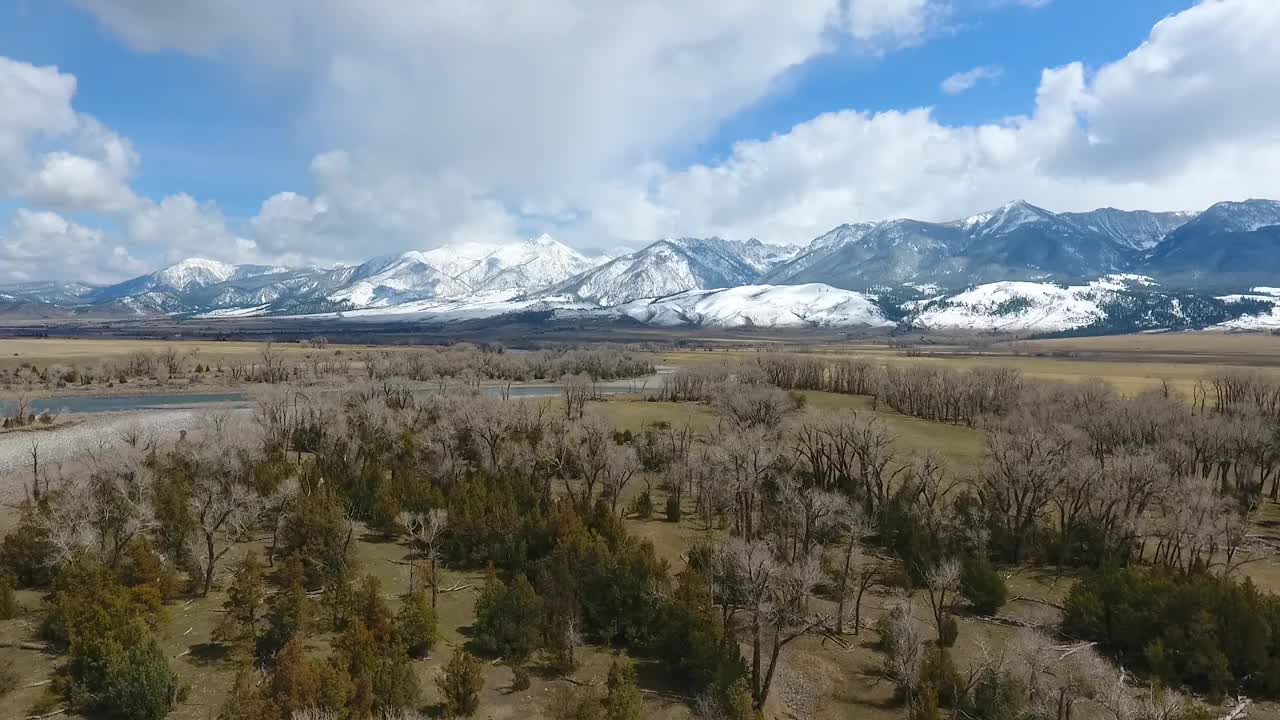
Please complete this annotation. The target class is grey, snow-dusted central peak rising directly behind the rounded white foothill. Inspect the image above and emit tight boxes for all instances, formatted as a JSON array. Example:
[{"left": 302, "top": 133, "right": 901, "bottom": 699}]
[{"left": 547, "top": 237, "right": 794, "bottom": 306}]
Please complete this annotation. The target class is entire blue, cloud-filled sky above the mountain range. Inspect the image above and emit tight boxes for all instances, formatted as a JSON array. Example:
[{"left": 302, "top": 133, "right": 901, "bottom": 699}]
[{"left": 0, "top": 0, "right": 1280, "bottom": 283}]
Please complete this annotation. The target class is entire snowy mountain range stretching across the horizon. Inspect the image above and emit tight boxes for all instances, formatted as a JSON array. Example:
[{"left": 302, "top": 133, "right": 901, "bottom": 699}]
[{"left": 0, "top": 200, "right": 1280, "bottom": 332}]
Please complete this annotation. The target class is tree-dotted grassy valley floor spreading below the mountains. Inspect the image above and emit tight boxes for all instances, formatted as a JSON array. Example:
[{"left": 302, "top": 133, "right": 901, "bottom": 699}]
[{"left": 0, "top": 333, "right": 1280, "bottom": 720}]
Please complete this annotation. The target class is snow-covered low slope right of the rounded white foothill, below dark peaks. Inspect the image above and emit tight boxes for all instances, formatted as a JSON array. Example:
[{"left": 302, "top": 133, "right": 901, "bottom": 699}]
[{"left": 911, "top": 275, "right": 1152, "bottom": 332}]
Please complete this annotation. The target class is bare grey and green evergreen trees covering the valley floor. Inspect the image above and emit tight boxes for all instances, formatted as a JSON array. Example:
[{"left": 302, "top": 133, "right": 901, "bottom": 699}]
[{"left": 0, "top": 347, "right": 1280, "bottom": 720}]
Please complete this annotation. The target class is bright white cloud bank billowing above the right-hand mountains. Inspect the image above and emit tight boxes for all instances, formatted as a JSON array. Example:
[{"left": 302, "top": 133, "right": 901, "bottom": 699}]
[{"left": 563, "top": 0, "right": 1280, "bottom": 242}]
